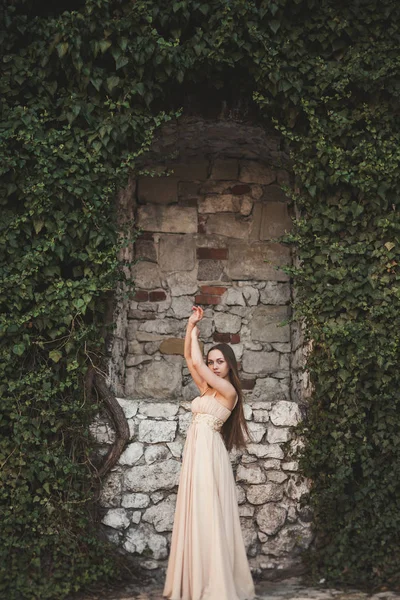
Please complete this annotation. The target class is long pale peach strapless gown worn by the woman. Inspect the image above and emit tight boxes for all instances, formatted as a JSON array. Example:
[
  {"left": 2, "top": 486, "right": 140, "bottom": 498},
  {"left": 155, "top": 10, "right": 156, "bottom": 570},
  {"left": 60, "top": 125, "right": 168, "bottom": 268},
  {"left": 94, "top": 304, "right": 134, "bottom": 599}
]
[{"left": 163, "top": 393, "right": 255, "bottom": 600}]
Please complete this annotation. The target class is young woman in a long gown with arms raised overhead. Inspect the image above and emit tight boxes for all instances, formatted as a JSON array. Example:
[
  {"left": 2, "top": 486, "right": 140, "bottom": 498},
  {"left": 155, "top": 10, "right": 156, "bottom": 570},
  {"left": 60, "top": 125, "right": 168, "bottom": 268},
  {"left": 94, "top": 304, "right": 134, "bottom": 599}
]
[{"left": 163, "top": 306, "right": 254, "bottom": 600}]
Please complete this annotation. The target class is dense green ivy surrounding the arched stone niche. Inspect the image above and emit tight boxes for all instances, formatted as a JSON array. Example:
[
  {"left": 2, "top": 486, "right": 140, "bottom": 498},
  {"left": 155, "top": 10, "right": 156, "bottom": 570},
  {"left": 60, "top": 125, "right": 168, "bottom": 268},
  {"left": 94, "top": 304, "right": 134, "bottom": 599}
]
[{"left": 0, "top": 0, "right": 400, "bottom": 600}]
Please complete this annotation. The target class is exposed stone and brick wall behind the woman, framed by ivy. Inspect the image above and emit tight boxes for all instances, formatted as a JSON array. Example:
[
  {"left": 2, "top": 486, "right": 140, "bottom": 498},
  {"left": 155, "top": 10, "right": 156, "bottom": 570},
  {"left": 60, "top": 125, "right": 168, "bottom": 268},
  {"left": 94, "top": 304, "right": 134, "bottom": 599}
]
[{"left": 92, "top": 120, "right": 311, "bottom": 574}]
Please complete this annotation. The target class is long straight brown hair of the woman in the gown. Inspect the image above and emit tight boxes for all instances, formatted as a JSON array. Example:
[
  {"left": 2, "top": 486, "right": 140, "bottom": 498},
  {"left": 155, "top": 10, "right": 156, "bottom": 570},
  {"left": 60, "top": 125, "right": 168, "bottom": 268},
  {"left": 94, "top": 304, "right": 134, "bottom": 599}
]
[{"left": 206, "top": 344, "right": 250, "bottom": 452}]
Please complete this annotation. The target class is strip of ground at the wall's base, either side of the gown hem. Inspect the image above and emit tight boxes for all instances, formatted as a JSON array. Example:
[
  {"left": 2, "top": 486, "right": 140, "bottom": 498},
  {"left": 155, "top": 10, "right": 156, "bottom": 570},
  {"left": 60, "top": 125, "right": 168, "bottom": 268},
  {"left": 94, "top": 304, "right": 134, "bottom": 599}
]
[{"left": 69, "top": 577, "right": 400, "bottom": 600}]
